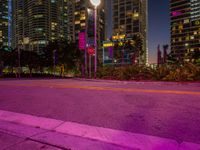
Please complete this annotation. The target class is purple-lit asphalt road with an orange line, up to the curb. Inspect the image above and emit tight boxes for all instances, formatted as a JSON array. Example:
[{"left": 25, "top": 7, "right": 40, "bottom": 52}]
[{"left": 0, "top": 79, "right": 200, "bottom": 144}]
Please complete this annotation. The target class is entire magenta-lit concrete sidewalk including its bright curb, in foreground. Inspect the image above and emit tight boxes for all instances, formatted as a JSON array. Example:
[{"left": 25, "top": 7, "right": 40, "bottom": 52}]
[{"left": 0, "top": 110, "right": 200, "bottom": 150}]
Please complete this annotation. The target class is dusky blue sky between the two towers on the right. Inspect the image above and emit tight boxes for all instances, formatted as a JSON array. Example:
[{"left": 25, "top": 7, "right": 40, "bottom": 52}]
[{"left": 148, "top": 0, "right": 170, "bottom": 63}]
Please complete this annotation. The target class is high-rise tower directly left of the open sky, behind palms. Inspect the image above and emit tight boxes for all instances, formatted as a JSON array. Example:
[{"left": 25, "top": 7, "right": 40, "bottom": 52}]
[{"left": 112, "top": 0, "right": 148, "bottom": 64}]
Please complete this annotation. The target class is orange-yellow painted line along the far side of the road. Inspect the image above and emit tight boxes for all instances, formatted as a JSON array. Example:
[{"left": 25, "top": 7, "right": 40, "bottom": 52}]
[{"left": 0, "top": 84, "right": 200, "bottom": 96}]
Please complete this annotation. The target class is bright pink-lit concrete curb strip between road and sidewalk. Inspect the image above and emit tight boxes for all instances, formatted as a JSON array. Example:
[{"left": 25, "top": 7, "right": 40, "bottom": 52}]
[{"left": 0, "top": 110, "right": 179, "bottom": 150}]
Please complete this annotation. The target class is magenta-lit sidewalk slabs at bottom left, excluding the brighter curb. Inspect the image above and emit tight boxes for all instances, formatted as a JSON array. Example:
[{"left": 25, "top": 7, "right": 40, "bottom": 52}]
[{"left": 0, "top": 121, "right": 133, "bottom": 150}]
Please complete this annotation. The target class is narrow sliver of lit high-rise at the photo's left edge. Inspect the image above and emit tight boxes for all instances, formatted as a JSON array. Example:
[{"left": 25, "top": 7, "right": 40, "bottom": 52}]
[{"left": 0, "top": 0, "right": 11, "bottom": 48}]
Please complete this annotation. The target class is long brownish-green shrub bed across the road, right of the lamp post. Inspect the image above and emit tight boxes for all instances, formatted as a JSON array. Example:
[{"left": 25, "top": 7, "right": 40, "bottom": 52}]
[{"left": 98, "top": 63, "right": 200, "bottom": 81}]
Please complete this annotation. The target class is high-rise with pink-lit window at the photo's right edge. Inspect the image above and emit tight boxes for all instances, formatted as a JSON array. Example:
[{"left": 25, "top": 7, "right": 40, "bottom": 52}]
[{"left": 170, "top": 0, "right": 200, "bottom": 61}]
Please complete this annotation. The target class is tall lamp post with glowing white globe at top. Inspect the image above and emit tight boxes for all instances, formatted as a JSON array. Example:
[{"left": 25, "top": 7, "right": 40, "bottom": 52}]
[{"left": 90, "top": 0, "right": 101, "bottom": 78}]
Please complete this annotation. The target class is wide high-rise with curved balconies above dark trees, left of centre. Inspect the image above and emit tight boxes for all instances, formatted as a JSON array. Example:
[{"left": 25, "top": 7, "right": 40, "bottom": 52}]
[{"left": 12, "top": 0, "right": 69, "bottom": 52}]
